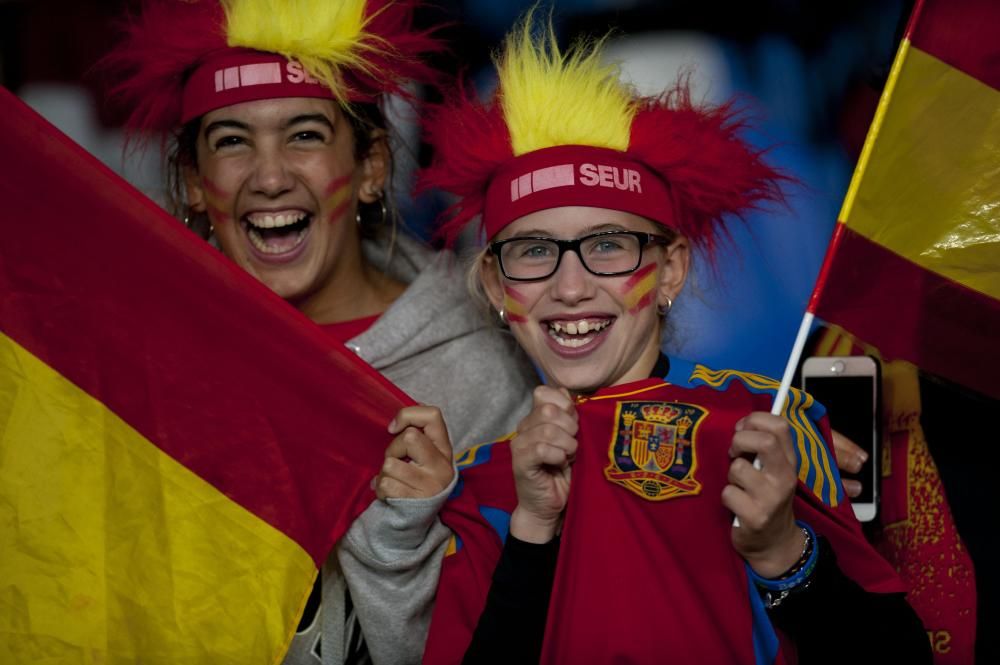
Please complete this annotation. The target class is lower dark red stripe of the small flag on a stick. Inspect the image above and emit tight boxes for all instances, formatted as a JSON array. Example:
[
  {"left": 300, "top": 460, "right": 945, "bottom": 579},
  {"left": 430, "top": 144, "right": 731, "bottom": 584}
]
[{"left": 809, "top": 224, "right": 1000, "bottom": 398}]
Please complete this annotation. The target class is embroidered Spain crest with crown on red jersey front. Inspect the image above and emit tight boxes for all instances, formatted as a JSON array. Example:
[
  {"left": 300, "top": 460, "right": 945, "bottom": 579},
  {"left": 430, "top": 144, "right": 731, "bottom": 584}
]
[{"left": 604, "top": 402, "right": 708, "bottom": 501}]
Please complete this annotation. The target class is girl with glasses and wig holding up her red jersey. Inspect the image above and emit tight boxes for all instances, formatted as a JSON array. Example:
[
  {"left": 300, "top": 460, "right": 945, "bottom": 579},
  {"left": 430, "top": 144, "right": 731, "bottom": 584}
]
[{"left": 414, "top": 10, "right": 930, "bottom": 663}]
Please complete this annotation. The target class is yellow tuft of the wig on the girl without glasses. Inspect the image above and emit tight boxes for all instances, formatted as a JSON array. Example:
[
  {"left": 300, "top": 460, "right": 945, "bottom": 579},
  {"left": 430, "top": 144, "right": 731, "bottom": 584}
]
[{"left": 222, "top": 0, "right": 380, "bottom": 99}]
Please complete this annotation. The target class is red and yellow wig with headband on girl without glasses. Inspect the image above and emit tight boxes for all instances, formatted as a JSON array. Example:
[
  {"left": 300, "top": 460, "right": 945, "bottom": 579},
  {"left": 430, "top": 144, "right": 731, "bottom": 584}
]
[{"left": 104, "top": 0, "right": 439, "bottom": 133}]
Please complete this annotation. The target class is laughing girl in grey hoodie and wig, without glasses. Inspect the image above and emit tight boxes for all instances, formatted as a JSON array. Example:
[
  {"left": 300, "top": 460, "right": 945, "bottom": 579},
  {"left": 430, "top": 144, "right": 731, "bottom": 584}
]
[{"left": 108, "top": 0, "right": 535, "bottom": 664}]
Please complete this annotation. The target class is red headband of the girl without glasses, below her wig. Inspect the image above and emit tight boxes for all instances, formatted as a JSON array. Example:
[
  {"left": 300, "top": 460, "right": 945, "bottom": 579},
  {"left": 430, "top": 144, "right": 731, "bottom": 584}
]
[{"left": 181, "top": 48, "right": 348, "bottom": 124}]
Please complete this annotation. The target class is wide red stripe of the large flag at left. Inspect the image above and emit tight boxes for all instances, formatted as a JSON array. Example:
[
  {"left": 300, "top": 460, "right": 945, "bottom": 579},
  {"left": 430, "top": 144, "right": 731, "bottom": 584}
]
[{"left": 0, "top": 89, "right": 413, "bottom": 567}]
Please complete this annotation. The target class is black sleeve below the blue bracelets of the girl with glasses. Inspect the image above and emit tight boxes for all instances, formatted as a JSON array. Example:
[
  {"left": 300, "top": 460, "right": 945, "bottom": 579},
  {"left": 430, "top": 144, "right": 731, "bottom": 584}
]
[{"left": 769, "top": 537, "right": 933, "bottom": 665}]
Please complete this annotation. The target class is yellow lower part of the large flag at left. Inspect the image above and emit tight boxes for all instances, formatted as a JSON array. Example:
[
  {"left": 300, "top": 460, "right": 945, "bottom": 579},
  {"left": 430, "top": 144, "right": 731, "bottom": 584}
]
[{"left": 0, "top": 333, "right": 316, "bottom": 665}]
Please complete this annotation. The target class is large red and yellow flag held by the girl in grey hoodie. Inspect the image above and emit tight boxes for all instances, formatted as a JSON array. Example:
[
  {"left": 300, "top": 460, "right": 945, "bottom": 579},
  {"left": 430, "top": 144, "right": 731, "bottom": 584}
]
[{"left": 0, "top": 88, "right": 411, "bottom": 665}]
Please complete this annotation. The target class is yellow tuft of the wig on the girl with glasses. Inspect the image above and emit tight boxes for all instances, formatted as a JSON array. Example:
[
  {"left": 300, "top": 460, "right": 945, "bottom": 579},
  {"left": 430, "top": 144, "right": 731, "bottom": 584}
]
[{"left": 497, "top": 10, "right": 638, "bottom": 156}]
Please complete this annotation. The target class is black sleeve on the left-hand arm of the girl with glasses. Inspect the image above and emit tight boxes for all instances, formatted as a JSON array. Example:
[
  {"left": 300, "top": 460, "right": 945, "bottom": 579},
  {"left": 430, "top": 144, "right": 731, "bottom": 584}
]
[{"left": 462, "top": 535, "right": 559, "bottom": 665}]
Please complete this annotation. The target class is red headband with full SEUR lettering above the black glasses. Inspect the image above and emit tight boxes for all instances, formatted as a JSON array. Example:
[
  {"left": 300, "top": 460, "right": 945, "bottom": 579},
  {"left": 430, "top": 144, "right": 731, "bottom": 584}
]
[{"left": 483, "top": 145, "right": 675, "bottom": 238}]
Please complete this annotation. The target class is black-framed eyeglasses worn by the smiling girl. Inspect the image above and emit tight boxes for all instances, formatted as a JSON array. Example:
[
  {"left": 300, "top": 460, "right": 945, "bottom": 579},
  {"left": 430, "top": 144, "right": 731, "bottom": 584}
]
[{"left": 490, "top": 231, "right": 672, "bottom": 282}]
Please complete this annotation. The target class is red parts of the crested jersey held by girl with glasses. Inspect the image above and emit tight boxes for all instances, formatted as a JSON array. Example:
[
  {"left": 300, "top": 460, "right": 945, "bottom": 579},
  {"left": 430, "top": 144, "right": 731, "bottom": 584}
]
[{"left": 425, "top": 379, "right": 903, "bottom": 663}]
